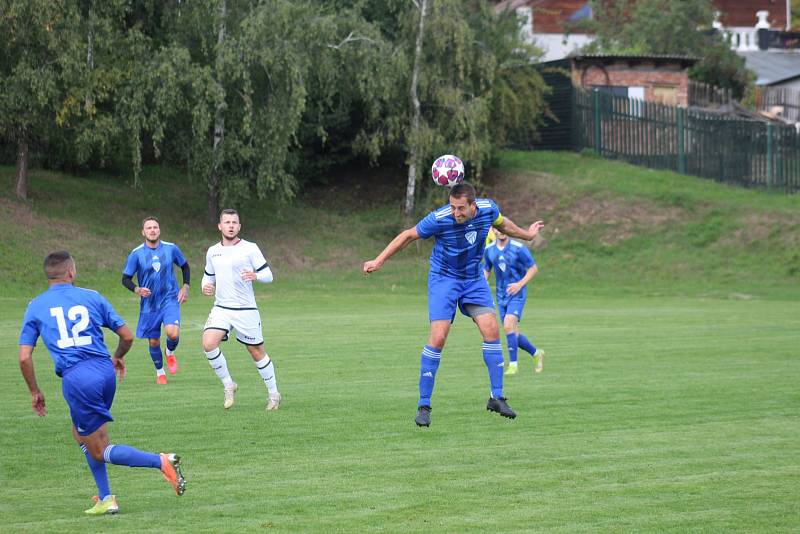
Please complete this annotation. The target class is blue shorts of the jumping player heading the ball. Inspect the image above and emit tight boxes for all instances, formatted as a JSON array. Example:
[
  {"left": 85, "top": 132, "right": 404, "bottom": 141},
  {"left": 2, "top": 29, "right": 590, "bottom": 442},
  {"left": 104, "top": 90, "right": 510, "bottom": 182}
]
[{"left": 428, "top": 273, "right": 494, "bottom": 322}]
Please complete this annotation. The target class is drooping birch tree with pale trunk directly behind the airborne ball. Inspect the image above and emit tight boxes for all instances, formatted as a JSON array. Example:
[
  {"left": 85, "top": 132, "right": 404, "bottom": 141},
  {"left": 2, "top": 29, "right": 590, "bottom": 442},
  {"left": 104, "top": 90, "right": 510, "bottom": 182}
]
[{"left": 361, "top": 0, "right": 547, "bottom": 215}]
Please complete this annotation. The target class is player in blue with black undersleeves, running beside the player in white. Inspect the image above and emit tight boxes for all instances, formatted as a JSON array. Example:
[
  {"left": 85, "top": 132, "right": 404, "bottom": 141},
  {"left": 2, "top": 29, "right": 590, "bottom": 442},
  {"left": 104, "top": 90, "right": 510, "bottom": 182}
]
[{"left": 122, "top": 217, "right": 190, "bottom": 384}]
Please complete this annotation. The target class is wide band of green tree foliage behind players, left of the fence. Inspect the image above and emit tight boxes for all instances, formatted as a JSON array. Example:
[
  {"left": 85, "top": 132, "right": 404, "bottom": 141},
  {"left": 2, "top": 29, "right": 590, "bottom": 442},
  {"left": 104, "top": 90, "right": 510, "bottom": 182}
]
[{"left": 0, "top": 0, "right": 547, "bottom": 210}]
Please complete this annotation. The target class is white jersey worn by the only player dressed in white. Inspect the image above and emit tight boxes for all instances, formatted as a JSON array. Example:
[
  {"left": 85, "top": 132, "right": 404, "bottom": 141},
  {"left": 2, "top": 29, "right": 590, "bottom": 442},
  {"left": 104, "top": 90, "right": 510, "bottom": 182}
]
[{"left": 205, "top": 239, "right": 269, "bottom": 310}]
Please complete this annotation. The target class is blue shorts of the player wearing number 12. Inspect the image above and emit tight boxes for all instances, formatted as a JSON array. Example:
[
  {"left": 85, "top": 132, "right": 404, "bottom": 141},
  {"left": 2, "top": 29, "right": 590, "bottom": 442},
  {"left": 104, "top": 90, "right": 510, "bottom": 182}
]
[{"left": 61, "top": 358, "right": 117, "bottom": 436}]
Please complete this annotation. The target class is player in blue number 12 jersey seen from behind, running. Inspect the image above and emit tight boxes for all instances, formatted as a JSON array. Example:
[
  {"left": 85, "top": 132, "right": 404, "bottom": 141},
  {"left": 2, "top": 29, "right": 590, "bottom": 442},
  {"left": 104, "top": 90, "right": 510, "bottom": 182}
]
[{"left": 19, "top": 251, "right": 186, "bottom": 515}]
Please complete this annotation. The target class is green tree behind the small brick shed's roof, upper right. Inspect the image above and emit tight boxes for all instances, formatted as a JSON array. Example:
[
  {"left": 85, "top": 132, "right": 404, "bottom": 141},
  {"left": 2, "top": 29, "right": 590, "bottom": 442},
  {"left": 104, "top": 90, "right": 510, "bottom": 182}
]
[{"left": 580, "top": 0, "right": 753, "bottom": 97}]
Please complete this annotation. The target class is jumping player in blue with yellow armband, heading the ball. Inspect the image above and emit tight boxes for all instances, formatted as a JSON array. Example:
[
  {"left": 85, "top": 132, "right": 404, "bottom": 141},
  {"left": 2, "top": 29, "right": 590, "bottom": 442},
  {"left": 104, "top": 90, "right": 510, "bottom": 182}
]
[{"left": 363, "top": 183, "right": 544, "bottom": 427}]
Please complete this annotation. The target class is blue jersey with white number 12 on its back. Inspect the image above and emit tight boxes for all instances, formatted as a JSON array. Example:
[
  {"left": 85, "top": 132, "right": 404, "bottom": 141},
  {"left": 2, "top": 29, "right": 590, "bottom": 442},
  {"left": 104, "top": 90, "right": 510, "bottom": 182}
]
[{"left": 19, "top": 284, "right": 125, "bottom": 376}]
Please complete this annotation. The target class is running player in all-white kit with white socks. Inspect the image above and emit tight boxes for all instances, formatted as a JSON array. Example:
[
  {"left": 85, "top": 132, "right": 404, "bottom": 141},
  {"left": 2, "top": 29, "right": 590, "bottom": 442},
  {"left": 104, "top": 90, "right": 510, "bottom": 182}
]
[{"left": 202, "top": 209, "right": 281, "bottom": 410}]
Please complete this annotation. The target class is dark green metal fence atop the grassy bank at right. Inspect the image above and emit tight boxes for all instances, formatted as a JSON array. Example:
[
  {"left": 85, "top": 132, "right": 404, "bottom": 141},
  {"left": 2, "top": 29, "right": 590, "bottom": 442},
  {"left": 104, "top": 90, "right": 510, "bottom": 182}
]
[{"left": 572, "top": 90, "right": 800, "bottom": 192}]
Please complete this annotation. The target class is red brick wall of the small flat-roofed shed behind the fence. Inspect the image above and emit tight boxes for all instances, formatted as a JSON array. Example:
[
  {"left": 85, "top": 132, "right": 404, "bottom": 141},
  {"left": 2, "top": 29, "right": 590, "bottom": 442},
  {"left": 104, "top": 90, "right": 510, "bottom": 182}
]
[{"left": 572, "top": 61, "right": 689, "bottom": 106}]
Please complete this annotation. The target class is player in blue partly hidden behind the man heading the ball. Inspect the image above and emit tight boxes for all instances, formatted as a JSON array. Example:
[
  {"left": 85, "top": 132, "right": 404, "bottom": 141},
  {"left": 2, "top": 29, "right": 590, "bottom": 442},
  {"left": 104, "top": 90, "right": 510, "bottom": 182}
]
[{"left": 483, "top": 230, "right": 544, "bottom": 375}]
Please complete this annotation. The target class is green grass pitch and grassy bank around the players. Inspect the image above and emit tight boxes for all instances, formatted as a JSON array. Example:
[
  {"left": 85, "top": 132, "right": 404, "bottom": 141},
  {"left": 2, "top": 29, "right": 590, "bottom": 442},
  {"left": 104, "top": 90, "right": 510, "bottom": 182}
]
[{"left": 0, "top": 154, "right": 800, "bottom": 532}]
